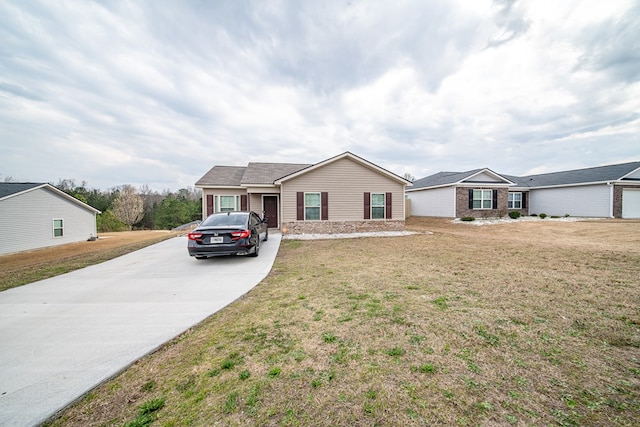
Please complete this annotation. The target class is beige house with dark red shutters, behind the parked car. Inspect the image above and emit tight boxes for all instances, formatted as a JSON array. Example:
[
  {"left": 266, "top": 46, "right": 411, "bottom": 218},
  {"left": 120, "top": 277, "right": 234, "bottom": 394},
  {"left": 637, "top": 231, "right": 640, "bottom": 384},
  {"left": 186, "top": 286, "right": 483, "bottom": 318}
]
[{"left": 195, "top": 152, "right": 411, "bottom": 234}]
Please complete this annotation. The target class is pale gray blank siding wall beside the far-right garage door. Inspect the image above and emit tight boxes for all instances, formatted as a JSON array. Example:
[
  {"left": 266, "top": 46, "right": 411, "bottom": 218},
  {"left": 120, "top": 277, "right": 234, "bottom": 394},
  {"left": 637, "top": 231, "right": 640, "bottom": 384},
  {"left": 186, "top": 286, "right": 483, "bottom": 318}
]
[{"left": 529, "top": 184, "right": 613, "bottom": 217}]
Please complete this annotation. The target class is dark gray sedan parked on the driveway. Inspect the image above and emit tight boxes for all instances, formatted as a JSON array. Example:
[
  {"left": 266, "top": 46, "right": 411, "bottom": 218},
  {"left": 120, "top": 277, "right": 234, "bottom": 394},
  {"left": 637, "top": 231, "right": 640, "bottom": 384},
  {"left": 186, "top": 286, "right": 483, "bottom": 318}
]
[{"left": 187, "top": 212, "right": 269, "bottom": 259}]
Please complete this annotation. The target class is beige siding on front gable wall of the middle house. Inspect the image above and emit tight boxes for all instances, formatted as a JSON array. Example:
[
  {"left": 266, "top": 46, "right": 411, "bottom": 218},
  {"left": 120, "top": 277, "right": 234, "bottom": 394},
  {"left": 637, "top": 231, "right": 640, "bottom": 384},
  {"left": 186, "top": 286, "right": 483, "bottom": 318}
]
[{"left": 281, "top": 158, "right": 404, "bottom": 222}]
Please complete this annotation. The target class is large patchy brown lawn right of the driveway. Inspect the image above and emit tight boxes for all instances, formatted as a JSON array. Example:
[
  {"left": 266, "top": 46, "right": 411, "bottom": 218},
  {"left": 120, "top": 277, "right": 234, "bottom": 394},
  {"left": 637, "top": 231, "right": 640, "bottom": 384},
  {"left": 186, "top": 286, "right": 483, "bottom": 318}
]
[{"left": 41, "top": 219, "right": 640, "bottom": 426}]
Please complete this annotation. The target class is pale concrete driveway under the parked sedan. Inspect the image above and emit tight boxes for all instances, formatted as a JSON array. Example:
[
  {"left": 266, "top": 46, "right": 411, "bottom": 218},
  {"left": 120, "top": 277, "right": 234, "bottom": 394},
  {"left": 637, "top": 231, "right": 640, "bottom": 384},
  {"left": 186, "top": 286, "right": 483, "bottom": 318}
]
[{"left": 0, "top": 234, "right": 281, "bottom": 426}]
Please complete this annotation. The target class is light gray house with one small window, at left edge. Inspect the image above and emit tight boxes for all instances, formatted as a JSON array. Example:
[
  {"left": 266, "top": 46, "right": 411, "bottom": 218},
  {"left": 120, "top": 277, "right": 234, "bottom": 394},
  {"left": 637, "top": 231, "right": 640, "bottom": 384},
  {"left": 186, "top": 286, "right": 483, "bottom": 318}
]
[{"left": 0, "top": 182, "right": 100, "bottom": 254}]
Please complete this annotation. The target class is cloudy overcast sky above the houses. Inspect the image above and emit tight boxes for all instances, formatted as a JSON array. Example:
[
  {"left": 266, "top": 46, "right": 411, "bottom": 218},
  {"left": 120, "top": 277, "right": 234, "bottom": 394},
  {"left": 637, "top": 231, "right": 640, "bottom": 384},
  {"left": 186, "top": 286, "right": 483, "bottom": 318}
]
[{"left": 0, "top": 0, "right": 640, "bottom": 191}]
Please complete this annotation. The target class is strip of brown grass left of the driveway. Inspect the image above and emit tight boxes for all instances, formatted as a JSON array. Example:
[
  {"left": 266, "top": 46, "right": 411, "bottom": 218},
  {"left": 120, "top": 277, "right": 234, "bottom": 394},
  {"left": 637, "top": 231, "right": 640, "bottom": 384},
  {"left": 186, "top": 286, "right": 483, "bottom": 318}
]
[{"left": 0, "top": 230, "right": 176, "bottom": 291}]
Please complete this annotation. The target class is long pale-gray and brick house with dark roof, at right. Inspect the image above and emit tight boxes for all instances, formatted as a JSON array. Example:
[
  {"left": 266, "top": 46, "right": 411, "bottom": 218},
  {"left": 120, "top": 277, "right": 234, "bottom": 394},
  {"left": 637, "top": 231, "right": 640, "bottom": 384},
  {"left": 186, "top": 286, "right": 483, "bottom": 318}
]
[{"left": 407, "top": 162, "right": 640, "bottom": 218}]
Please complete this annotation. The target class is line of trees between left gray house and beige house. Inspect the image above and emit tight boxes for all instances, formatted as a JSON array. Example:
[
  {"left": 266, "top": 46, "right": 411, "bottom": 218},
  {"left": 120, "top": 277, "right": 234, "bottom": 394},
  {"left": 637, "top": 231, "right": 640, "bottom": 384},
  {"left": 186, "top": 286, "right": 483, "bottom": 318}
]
[{"left": 55, "top": 179, "right": 202, "bottom": 232}]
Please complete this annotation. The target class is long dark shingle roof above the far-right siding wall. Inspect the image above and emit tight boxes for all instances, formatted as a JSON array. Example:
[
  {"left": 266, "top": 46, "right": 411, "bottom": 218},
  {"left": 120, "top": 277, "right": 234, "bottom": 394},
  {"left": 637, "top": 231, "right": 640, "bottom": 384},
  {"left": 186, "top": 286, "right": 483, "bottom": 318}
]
[{"left": 511, "top": 162, "right": 640, "bottom": 187}]
